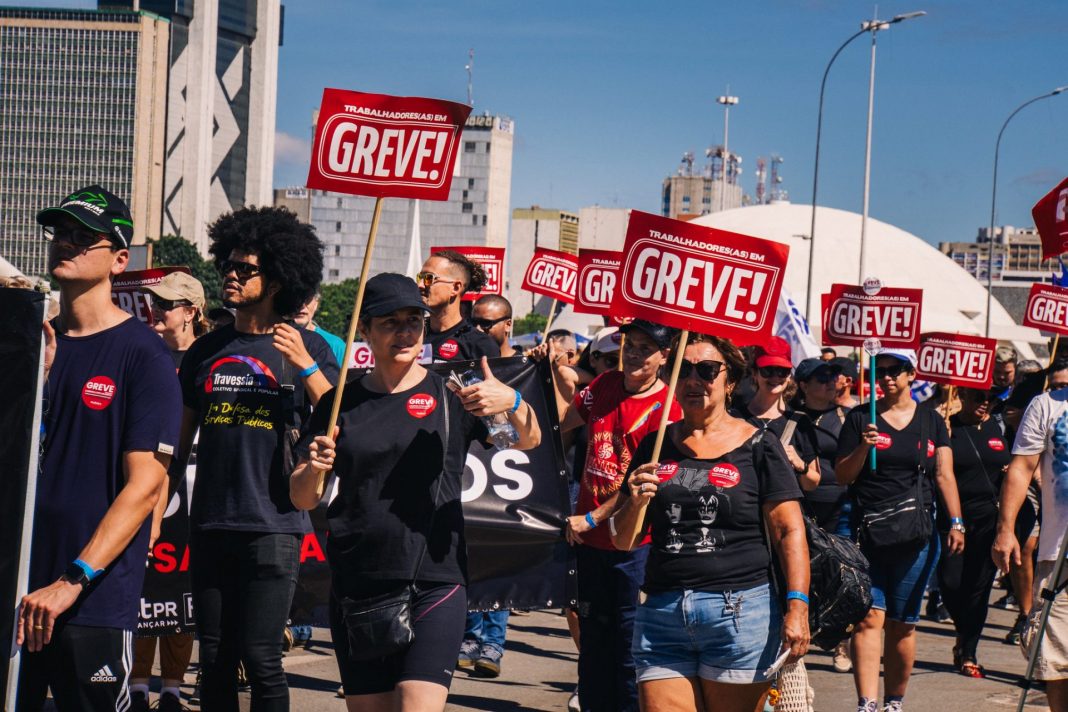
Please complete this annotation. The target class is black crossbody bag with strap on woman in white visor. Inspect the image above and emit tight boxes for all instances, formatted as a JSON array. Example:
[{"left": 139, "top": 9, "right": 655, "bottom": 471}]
[{"left": 860, "top": 409, "right": 933, "bottom": 549}]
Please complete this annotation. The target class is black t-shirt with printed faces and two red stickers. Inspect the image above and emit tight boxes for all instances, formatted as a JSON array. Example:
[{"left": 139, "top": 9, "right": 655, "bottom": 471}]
[{"left": 619, "top": 432, "right": 801, "bottom": 594}]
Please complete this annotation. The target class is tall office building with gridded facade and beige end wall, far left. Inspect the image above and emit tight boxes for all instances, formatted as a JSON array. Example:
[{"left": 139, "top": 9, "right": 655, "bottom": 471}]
[{"left": 0, "top": 7, "right": 170, "bottom": 274}]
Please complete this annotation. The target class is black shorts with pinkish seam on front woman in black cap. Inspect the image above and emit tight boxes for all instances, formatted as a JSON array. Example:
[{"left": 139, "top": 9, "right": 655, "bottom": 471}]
[{"left": 330, "top": 582, "right": 467, "bottom": 695}]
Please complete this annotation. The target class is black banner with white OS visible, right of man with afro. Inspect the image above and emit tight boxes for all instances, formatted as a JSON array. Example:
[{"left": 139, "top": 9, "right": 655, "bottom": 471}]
[{"left": 293, "top": 357, "right": 574, "bottom": 626}]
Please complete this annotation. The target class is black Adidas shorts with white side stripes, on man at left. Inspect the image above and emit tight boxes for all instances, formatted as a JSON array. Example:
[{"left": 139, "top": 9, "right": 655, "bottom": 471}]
[{"left": 15, "top": 626, "right": 134, "bottom": 712}]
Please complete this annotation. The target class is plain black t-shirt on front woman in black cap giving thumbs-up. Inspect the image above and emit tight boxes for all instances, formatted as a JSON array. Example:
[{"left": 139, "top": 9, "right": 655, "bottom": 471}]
[{"left": 297, "top": 371, "right": 488, "bottom": 595}]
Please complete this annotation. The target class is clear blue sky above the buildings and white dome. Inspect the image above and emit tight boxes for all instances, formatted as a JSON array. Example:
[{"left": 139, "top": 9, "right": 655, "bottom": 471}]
[{"left": 16, "top": 0, "right": 1068, "bottom": 243}]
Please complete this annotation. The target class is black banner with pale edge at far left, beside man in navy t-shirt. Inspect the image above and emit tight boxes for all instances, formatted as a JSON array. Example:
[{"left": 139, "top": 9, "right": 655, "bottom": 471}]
[{"left": 0, "top": 288, "right": 46, "bottom": 709}]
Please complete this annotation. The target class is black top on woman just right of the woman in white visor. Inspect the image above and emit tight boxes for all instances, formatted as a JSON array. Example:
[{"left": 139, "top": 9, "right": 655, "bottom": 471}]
[{"left": 938, "top": 415, "right": 1012, "bottom": 528}]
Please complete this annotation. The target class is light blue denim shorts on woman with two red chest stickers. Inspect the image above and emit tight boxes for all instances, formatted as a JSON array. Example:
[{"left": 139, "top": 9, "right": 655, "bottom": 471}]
[{"left": 633, "top": 584, "right": 783, "bottom": 684}]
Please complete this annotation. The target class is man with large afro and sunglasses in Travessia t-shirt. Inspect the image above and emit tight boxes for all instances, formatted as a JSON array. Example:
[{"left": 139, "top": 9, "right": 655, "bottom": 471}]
[{"left": 178, "top": 207, "right": 339, "bottom": 710}]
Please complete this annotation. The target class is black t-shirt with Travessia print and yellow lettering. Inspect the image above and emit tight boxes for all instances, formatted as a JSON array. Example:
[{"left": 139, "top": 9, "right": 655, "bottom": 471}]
[{"left": 178, "top": 325, "right": 337, "bottom": 534}]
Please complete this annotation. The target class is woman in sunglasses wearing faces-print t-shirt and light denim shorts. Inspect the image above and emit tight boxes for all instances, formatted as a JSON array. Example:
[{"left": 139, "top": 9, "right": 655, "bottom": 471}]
[{"left": 613, "top": 334, "right": 808, "bottom": 712}]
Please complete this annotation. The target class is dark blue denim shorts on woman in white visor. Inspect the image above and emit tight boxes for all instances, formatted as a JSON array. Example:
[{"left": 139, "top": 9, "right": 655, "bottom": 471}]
[{"left": 861, "top": 529, "right": 939, "bottom": 623}]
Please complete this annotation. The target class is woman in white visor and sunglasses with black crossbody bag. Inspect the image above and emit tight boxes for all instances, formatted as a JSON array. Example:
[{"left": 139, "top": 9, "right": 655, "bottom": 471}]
[{"left": 834, "top": 349, "right": 964, "bottom": 712}]
